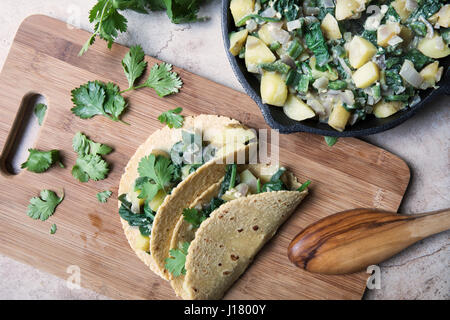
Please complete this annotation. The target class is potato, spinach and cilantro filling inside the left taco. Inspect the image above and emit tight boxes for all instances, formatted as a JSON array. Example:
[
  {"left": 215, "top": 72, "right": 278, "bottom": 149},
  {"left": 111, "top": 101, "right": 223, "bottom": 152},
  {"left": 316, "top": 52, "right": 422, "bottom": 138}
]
[{"left": 119, "top": 130, "right": 217, "bottom": 251}]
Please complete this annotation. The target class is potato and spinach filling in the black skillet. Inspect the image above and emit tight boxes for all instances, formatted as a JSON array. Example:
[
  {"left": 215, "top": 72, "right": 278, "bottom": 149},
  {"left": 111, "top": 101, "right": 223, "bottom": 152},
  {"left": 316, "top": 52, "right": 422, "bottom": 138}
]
[{"left": 230, "top": 0, "right": 450, "bottom": 131}]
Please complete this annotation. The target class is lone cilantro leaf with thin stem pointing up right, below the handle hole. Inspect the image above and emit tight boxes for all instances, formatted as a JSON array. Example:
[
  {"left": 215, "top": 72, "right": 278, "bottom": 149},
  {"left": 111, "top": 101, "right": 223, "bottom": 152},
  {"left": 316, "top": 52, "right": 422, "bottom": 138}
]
[{"left": 27, "top": 190, "right": 64, "bottom": 221}]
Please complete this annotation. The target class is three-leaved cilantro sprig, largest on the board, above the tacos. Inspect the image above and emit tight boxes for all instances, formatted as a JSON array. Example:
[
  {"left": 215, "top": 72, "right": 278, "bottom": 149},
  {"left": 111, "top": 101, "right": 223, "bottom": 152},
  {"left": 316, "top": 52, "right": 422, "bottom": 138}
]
[{"left": 71, "top": 45, "right": 183, "bottom": 122}]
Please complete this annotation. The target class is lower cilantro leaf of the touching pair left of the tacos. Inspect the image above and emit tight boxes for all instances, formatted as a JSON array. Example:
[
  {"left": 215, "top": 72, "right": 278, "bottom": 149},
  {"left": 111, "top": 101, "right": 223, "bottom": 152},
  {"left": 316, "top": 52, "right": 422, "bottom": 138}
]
[{"left": 72, "top": 154, "right": 109, "bottom": 182}]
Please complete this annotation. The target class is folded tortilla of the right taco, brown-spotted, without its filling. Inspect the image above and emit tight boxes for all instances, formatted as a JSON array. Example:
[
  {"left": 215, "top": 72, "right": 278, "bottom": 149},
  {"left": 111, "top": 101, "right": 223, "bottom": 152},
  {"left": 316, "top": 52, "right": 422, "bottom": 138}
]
[{"left": 167, "top": 165, "right": 308, "bottom": 300}]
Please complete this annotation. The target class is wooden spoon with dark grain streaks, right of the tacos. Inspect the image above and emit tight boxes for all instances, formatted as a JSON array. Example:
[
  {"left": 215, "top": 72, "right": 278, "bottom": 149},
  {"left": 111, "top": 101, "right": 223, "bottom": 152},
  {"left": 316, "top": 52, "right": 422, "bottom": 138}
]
[{"left": 288, "top": 209, "right": 450, "bottom": 274}]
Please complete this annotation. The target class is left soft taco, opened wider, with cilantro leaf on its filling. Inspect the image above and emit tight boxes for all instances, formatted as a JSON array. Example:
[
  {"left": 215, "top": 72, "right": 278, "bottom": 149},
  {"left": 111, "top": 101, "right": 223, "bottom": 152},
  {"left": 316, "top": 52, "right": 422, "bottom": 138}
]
[{"left": 118, "top": 115, "right": 256, "bottom": 278}]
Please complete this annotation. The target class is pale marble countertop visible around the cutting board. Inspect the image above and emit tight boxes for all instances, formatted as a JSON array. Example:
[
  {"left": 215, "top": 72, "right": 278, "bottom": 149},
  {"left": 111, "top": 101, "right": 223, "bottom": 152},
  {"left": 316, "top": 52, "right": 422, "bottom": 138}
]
[{"left": 0, "top": 0, "right": 450, "bottom": 299}]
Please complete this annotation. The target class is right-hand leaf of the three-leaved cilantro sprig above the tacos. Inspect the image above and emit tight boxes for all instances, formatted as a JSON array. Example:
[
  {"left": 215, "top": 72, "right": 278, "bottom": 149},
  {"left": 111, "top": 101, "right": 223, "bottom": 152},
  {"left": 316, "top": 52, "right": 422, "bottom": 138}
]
[{"left": 143, "top": 62, "right": 183, "bottom": 97}]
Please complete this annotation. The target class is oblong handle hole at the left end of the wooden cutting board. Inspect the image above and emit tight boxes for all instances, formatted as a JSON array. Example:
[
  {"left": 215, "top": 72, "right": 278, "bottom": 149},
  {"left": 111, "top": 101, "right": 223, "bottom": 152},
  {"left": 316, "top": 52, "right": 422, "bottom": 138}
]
[{"left": 0, "top": 93, "right": 49, "bottom": 176}]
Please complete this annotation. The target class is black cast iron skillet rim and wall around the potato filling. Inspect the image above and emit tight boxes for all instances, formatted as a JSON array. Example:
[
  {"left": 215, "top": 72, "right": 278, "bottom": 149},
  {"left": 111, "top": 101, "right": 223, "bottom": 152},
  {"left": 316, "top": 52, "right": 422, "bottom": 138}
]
[{"left": 222, "top": 0, "right": 450, "bottom": 137}]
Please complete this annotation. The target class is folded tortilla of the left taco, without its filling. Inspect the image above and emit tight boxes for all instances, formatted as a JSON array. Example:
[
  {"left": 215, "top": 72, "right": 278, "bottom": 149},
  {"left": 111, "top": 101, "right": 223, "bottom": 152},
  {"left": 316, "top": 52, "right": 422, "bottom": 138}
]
[{"left": 118, "top": 115, "right": 256, "bottom": 279}]
